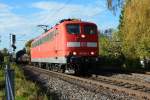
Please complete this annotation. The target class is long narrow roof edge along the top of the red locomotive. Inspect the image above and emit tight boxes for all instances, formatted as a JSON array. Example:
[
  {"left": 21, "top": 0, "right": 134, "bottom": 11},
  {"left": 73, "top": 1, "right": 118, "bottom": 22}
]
[{"left": 32, "top": 19, "right": 96, "bottom": 43}]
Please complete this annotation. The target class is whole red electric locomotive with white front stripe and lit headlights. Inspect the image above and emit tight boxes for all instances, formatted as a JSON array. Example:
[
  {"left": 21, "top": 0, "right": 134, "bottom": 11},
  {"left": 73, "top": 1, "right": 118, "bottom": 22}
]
[{"left": 31, "top": 19, "right": 99, "bottom": 74}]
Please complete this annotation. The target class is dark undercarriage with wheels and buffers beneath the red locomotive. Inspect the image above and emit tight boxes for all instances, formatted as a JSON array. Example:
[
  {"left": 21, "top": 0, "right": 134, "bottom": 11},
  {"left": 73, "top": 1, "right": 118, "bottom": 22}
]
[{"left": 32, "top": 56, "right": 98, "bottom": 74}]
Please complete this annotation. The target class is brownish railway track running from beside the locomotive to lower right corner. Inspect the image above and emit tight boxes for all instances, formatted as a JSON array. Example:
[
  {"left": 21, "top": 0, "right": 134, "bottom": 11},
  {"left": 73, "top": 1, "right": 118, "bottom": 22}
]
[{"left": 25, "top": 66, "right": 150, "bottom": 100}]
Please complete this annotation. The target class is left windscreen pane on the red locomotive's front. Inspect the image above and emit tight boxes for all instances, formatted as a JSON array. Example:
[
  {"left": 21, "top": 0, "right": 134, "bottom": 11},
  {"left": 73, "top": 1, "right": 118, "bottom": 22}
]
[{"left": 67, "top": 24, "right": 80, "bottom": 34}]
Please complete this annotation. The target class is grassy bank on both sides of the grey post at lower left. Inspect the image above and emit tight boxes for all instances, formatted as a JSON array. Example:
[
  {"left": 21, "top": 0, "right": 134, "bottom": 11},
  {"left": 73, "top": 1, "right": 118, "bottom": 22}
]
[{"left": 0, "top": 64, "right": 50, "bottom": 100}]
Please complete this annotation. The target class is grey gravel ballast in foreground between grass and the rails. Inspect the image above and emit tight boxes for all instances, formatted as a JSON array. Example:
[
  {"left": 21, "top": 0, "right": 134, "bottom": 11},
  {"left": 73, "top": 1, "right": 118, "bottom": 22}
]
[{"left": 24, "top": 68, "right": 138, "bottom": 100}]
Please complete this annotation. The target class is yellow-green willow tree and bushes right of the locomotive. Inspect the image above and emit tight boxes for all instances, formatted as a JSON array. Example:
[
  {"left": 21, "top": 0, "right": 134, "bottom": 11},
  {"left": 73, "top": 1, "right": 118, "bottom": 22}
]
[{"left": 100, "top": 0, "right": 150, "bottom": 70}]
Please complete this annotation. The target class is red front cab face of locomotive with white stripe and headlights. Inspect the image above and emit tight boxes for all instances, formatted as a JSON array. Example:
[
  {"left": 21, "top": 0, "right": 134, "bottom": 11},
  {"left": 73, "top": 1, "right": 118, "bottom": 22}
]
[{"left": 64, "top": 21, "right": 99, "bottom": 73}]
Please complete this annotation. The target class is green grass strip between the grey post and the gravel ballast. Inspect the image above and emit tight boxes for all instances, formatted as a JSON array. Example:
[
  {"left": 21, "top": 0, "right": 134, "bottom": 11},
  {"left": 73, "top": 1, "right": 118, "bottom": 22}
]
[{"left": 13, "top": 65, "right": 48, "bottom": 100}]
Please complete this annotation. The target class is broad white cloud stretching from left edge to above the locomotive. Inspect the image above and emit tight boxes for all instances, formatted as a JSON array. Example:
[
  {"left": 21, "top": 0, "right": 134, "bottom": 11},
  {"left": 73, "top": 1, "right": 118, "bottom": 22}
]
[{"left": 0, "top": 1, "right": 104, "bottom": 34}]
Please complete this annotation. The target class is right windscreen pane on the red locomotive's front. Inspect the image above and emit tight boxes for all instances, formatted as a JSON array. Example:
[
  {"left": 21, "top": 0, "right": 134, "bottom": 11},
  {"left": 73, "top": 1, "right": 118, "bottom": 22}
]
[{"left": 84, "top": 25, "right": 97, "bottom": 34}]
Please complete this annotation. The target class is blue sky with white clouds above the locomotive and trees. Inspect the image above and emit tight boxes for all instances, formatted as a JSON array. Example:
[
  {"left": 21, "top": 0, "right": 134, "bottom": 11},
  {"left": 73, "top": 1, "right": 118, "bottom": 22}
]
[{"left": 0, "top": 0, "right": 120, "bottom": 50}]
